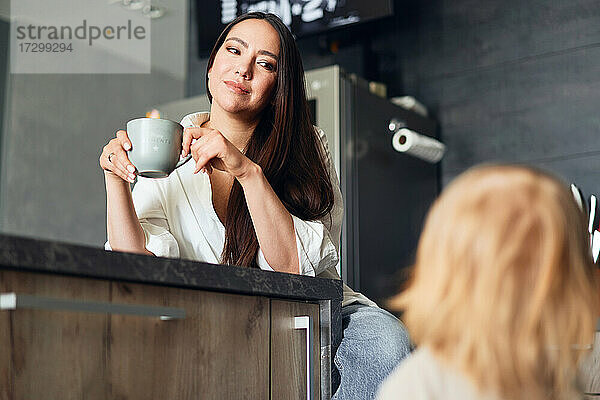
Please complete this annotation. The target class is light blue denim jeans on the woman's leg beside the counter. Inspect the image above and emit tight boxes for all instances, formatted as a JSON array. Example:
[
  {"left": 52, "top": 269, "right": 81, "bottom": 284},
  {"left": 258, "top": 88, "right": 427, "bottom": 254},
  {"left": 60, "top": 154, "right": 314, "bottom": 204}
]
[{"left": 332, "top": 303, "right": 411, "bottom": 400}]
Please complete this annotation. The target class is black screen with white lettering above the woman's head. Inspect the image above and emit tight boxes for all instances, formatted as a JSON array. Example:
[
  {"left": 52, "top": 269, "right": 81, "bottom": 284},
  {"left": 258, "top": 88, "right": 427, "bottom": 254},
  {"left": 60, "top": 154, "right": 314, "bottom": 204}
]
[{"left": 197, "top": 0, "right": 393, "bottom": 57}]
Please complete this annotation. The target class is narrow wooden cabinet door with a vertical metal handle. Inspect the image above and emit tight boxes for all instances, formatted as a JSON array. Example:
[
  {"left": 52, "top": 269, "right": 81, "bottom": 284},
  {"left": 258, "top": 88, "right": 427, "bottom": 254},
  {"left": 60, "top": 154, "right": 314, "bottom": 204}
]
[{"left": 271, "top": 300, "right": 321, "bottom": 400}]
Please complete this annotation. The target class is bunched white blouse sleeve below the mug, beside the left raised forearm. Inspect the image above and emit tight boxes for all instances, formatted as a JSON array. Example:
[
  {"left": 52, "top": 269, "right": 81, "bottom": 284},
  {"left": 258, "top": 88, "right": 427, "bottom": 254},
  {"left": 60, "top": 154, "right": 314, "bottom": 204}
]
[{"left": 104, "top": 177, "right": 179, "bottom": 258}]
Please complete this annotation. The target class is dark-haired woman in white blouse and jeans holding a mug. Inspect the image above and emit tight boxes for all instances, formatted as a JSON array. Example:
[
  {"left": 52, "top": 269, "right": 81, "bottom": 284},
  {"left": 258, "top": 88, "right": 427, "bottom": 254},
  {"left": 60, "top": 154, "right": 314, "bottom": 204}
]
[{"left": 100, "top": 13, "right": 409, "bottom": 399}]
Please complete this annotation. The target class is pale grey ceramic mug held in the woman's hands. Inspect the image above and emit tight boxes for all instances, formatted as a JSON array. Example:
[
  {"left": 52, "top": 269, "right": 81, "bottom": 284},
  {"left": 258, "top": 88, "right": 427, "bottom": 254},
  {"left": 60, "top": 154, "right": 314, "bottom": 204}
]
[{"left": 127, "top": 118, "right": 192, "bottom": 178}]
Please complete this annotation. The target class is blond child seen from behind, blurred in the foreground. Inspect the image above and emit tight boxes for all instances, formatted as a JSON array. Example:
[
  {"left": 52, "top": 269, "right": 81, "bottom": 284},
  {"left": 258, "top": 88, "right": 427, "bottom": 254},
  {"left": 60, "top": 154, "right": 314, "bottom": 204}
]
[{"left": 378, "top": 166, "right": 598, "bottom": 400}]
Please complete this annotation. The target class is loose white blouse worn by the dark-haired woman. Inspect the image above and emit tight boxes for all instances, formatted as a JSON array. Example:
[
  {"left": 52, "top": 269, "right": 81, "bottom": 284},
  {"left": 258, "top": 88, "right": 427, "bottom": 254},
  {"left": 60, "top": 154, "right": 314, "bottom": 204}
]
[{"left": 105, "top": 112, "right": 375, "bottom": 305}]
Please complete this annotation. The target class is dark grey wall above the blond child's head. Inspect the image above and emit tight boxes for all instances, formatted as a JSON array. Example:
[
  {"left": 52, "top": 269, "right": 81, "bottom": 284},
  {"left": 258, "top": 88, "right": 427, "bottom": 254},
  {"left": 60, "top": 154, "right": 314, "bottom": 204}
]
[{"left": 188, "top": 0, "right": 600, "bottom": 194}]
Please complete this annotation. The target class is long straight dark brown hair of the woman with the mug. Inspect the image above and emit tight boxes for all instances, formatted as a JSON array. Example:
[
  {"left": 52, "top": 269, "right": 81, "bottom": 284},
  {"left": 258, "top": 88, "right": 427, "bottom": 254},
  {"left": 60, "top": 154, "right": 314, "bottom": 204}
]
[{"left": 206, "top": 12, "right": 333, "bottom": 268}]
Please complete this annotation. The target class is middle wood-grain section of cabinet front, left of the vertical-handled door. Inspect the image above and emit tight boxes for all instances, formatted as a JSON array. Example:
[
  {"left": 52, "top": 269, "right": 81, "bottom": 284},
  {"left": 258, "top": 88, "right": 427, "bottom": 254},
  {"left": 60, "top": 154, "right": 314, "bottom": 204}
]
[{"left": 109, "top": 283, "right": 269, "bottom": 400}]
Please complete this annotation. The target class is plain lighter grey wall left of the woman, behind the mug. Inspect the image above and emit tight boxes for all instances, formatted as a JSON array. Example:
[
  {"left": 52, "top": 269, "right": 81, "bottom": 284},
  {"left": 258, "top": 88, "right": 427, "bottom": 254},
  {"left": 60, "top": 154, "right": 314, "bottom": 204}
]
[{"left": 0, "top": 0, "right": 188, "bottom": 247}]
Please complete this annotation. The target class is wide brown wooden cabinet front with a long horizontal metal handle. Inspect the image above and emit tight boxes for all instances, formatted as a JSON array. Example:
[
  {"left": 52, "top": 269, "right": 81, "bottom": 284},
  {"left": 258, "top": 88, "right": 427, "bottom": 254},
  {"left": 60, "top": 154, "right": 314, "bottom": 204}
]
[{"left": 0, "top": 271, "right": 270, "bottom": 400}]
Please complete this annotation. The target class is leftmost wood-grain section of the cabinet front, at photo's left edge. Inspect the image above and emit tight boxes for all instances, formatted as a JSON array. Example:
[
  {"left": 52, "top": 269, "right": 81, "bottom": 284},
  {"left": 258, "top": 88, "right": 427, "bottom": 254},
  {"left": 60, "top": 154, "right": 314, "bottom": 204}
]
[{"left": 0, "top": 271, "right": 109, "bottom": 400}]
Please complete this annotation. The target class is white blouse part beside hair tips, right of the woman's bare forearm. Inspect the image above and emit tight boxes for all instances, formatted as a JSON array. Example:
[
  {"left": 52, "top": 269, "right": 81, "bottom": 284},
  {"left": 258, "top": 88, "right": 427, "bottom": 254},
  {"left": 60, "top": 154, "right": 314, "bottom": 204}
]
[{"left": 258, "top": 128, "right": 344, "bottom": 276}]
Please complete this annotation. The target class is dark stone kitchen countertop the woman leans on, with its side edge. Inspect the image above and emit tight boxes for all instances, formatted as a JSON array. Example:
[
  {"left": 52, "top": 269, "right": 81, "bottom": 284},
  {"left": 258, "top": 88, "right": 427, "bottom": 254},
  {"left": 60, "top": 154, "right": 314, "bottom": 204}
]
[{"left": 0, "top": 235, "right": 342, "bottom": 395}]
